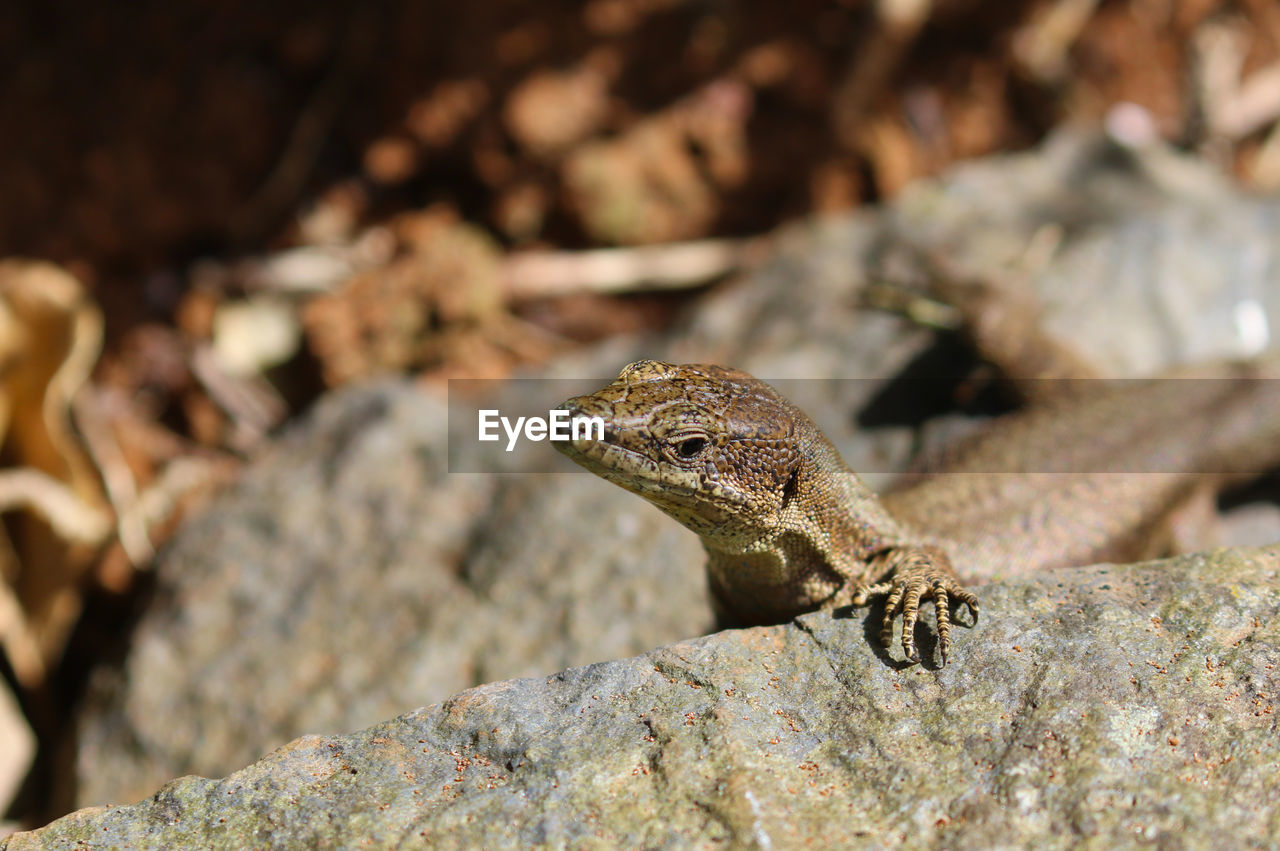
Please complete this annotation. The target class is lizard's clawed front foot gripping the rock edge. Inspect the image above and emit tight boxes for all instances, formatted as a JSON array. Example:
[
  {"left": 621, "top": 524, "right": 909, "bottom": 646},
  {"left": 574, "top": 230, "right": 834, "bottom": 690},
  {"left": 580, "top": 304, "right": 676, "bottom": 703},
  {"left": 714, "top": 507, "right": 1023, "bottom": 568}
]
[{"left": 851, "top": 548, "right": 978, "bottom": 664}]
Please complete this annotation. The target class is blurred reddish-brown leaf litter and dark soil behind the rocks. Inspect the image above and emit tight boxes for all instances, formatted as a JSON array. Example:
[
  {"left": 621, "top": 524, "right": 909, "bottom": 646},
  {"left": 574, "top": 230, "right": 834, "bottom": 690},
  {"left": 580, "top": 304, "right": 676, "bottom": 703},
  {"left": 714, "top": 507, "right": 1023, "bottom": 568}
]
[{"left": 0, "top": 0, "right": 1280, "bottom": 824}]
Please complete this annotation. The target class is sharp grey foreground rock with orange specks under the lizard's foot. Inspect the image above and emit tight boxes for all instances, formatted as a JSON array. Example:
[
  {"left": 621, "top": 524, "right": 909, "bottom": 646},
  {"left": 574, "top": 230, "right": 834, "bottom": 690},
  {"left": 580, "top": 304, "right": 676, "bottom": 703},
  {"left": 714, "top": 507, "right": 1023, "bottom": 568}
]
[{"left": 12, "top": 546, "right": 1280, "bottom": 851}]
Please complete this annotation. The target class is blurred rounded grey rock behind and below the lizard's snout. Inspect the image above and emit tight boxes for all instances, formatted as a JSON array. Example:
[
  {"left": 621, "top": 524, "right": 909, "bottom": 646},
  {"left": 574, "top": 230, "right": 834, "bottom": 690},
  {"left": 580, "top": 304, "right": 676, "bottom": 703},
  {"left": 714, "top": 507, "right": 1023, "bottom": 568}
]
[{"left": 77, "top": 381, "right": 710, "bottom": 804}]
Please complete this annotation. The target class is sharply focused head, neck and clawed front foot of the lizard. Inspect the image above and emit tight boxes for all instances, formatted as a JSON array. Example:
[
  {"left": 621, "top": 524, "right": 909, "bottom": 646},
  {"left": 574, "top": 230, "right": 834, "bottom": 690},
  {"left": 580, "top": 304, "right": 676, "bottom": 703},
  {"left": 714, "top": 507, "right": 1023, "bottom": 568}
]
[{"left": 556, "top": 361, "right": 978, "bottom": 662}]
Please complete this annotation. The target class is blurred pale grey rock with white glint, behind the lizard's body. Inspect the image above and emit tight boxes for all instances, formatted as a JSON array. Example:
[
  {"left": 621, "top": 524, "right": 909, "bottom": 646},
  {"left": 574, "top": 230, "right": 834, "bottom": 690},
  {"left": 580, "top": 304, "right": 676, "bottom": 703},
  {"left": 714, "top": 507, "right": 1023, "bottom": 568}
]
[{"left": 877, "top": 131, "right": 1280, "bottom": 376}]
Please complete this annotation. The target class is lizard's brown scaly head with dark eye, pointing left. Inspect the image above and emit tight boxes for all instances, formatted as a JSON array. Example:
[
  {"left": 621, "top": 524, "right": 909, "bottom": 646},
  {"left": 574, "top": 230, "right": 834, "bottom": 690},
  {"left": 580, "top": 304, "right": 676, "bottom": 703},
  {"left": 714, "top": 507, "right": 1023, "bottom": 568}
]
[{"left": 556, "top": 361, "right": 803, "bottom": 545}]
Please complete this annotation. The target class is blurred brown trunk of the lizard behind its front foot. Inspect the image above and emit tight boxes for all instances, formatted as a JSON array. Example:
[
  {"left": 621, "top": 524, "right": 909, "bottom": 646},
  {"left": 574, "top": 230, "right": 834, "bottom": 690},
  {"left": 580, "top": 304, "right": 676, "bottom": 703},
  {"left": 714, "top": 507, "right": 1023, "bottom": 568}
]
[{"left": 884, "top": 357, "right": 1280, "bottom": 578}]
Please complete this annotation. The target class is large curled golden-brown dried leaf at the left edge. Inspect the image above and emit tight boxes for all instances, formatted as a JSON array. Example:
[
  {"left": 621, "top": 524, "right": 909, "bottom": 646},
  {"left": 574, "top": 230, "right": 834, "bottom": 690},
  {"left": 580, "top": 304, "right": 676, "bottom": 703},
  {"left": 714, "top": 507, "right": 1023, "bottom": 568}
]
[{"left": 0, "top": 260, "right": 111, "bottom": 686}]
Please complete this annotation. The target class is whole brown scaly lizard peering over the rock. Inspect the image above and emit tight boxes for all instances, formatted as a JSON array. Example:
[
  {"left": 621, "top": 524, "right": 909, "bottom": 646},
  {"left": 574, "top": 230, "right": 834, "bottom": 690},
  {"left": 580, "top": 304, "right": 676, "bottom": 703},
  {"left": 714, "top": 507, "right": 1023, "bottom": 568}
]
[{"left": 556, "top": 361, "right": 1280, "bottom": 664}]
